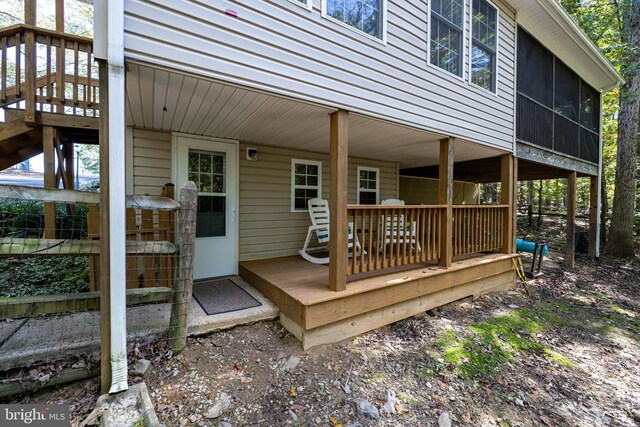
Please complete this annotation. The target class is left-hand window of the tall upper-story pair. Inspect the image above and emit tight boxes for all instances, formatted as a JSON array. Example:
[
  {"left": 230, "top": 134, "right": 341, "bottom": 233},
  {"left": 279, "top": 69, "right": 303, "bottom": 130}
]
[{"left": 429, "top": 0, "right": 464, "bottom": 77}]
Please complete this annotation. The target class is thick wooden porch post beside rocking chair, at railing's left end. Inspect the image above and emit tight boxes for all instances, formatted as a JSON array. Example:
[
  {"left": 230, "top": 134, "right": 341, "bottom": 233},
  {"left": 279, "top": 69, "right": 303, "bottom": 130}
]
[{"left": 329, "top": 110, "right": 349, "bottom": 291}]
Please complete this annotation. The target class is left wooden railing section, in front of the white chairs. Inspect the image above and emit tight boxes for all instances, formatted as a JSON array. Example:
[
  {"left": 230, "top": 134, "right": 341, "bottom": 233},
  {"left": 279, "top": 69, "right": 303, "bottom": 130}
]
[{"left": 347, "top": 205, "right": 445, "bottom": 274}]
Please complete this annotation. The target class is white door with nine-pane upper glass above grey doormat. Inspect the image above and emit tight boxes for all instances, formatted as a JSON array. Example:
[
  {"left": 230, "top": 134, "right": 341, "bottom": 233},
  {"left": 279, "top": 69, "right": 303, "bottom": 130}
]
[{"left": 173, "top": 135, "right": 238, "bottom": 279}]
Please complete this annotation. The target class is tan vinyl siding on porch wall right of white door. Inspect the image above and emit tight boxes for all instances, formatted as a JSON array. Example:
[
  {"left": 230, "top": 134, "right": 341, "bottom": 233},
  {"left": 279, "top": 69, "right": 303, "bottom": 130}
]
[{"left": 239, "top": 143, "right": 398, "bottom": 261}]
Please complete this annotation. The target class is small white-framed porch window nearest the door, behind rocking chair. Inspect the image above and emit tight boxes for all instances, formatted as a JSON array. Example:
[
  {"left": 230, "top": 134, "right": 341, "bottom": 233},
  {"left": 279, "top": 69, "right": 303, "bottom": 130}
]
[{"left": 291, "top": 159, "right": 322, "bottom": 212}]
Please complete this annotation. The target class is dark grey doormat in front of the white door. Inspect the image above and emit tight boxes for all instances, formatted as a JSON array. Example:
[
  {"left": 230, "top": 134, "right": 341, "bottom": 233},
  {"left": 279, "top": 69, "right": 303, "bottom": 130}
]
[{"left": 193, "top": 279, "right": 262, "bottom": 316}]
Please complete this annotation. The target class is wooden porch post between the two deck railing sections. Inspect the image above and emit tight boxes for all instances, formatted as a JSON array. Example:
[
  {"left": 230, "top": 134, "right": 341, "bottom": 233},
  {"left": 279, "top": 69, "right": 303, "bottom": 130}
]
[{"left": 438, "top": 138, "right": 455, "bottom": 268}]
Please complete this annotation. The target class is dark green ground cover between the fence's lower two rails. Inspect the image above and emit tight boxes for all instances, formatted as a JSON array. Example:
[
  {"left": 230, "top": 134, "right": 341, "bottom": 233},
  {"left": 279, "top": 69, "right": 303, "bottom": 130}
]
[{"left": 0, "top": 257, "right": 89, "bottom": 297}]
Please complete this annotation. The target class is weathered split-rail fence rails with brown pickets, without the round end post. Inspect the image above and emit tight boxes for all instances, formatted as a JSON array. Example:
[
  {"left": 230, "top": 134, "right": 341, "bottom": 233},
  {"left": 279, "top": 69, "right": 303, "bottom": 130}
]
[{"left": 0, "top": 185, "right": 185, "bottom": 318}]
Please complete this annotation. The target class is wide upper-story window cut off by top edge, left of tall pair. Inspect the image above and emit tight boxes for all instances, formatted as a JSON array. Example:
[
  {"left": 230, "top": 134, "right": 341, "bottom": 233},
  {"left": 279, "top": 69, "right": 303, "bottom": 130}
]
[{"left": 322, "top": 0, "right": 386, "bottom": 40}]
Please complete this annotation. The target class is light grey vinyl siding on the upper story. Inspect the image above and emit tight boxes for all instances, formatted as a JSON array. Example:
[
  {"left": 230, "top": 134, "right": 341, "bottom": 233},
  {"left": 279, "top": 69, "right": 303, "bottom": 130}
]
[{"left": 125, "top": 0, "right": 515, "bottom": 149}]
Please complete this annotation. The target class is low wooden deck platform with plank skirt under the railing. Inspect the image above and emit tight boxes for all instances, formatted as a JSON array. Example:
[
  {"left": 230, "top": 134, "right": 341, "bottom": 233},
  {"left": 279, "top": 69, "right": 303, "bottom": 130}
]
[{"left": 240, "top": 254, "right": 515, "bottom": 348}]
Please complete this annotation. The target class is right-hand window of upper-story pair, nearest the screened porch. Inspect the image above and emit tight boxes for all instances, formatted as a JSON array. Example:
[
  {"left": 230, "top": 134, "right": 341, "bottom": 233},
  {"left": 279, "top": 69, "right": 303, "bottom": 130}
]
[{"left": 471, "top": 0, "right": 498, "bottom": 92}]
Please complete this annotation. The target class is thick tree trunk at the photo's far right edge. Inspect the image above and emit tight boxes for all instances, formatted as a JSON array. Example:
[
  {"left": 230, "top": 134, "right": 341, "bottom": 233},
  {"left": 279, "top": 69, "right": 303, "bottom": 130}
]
[{"left": 606, "top": 1, "right": 640, "bottom": 257}]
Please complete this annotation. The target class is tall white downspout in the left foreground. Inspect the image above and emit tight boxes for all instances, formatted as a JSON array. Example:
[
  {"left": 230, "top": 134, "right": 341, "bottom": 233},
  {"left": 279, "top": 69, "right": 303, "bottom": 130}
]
[{"left": 107, "top": 0, "right": 128, "bottom": 393}]
